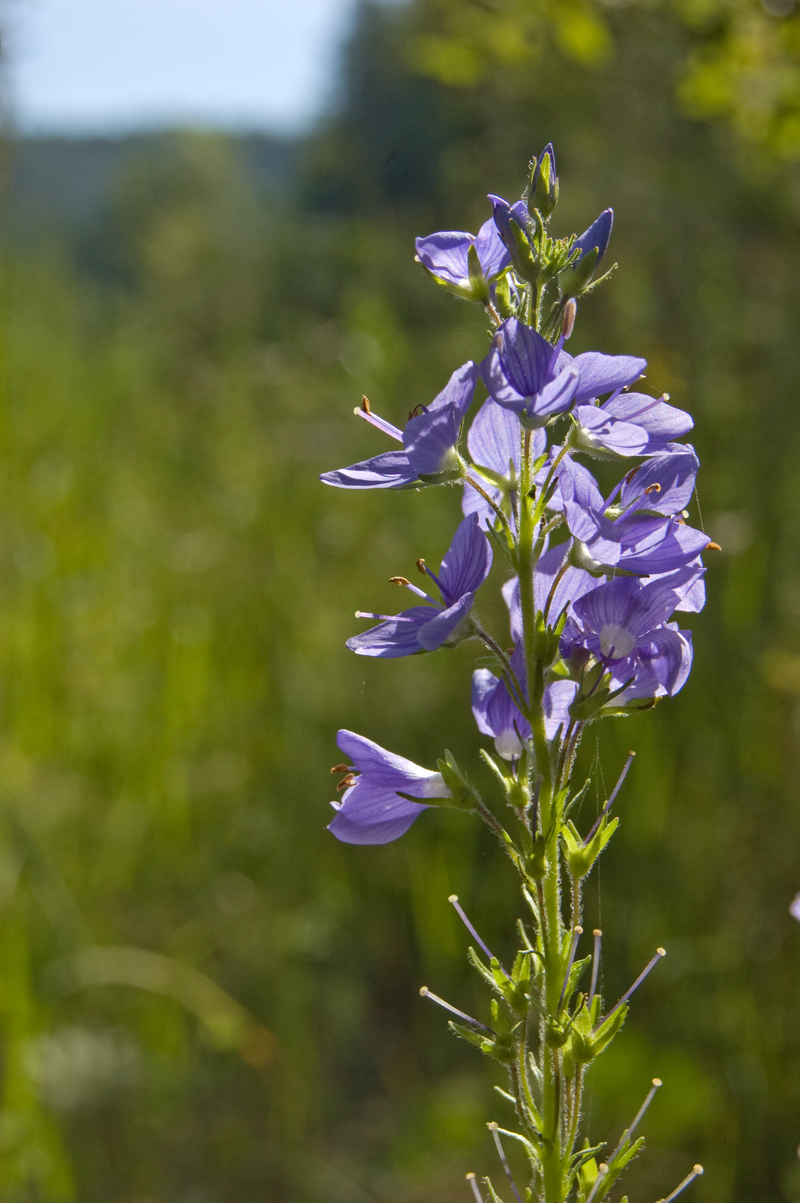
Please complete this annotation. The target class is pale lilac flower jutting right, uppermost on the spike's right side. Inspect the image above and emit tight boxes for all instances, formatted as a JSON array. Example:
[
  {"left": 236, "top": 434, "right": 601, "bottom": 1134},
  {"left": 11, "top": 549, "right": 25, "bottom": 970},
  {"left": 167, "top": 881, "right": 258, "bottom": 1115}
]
[{"left": 570, "top": 392, "right": 694, "bottom": 460}]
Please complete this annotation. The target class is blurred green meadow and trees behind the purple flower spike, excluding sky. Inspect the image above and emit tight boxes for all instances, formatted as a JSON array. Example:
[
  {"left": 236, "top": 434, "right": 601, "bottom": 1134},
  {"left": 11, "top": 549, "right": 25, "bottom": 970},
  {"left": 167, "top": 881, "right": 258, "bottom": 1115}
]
[{"left": 0, "top": 0, "right": 800, "bottom": 1203}]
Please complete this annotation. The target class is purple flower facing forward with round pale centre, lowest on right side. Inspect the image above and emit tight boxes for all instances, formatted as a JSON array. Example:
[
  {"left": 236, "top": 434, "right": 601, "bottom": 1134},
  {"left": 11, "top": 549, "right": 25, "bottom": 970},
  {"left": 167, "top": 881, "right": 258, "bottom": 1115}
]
[{"left": 561, "top": 576, "right": 692, "bottom": 705}]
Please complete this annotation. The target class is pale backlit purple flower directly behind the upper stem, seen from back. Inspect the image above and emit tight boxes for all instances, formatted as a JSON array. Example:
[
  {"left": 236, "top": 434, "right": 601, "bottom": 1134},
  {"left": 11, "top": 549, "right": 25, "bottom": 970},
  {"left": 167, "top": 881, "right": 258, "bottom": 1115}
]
[{"left": 462, "top": 397, "right": 547, "bottom": 526}]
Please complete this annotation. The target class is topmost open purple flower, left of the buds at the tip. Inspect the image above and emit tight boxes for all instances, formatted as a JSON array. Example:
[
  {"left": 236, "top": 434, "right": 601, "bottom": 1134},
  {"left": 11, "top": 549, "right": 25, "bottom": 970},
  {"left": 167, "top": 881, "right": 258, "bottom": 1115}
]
[{"left": 415, "top": 218, "right": 511, "bottom": 302}]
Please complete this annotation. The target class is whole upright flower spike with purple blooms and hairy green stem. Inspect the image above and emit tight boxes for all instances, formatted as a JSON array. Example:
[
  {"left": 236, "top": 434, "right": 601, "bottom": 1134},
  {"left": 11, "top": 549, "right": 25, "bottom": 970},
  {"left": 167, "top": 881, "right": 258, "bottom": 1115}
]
[{"left": 322, "top": 146, "right": 716, "bottom": 1203}]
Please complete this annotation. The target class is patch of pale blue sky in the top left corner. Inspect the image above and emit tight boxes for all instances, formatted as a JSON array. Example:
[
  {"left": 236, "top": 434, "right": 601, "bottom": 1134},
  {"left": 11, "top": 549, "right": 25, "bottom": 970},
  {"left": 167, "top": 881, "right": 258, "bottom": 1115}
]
[{"left": 2, "top": 0, "right": 365, "bottom": 134}]
